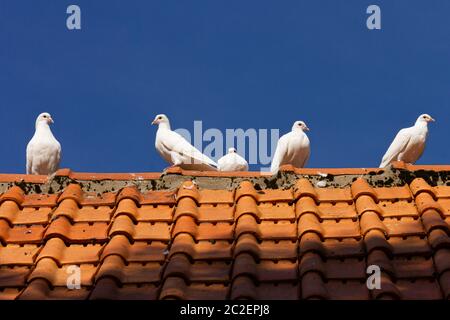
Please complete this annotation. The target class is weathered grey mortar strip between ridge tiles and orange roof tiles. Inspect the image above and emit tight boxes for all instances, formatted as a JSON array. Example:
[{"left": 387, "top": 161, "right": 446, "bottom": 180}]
[{"left": 0, "top": 168, "right": 450, "bottom": 194}]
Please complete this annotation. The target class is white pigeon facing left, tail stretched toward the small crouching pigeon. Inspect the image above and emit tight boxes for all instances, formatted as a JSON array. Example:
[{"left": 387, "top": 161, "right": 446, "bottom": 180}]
[{"left": 152, "top": 114, "right": 217, "bottom": 171}]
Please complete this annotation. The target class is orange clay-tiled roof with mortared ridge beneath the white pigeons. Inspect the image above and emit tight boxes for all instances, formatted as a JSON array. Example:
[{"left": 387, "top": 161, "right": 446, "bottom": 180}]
[{"left": 0, "top": 163, "right": 450, "bottom": 299}]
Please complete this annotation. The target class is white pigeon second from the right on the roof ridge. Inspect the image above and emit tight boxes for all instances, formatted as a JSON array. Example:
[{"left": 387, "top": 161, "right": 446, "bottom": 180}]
[{"left": 270, "top": 121, "right": 310, "bottom": 174}]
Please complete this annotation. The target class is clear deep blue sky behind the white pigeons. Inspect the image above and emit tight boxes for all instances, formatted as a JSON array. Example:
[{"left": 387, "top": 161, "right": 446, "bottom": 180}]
[{"left": 0, "top": 0, "right": 450, "bottom": 173}]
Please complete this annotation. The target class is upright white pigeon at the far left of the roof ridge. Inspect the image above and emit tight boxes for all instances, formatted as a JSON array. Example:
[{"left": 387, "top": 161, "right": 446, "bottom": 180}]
[{"left": 27, "top": 112, "right": 61, "bottom": 175}]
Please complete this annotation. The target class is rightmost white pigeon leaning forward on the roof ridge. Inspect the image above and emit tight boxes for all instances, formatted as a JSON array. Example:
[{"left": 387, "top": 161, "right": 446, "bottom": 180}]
[{"left": 380, "top": 114, "right": 435, "bottom": 168}]
